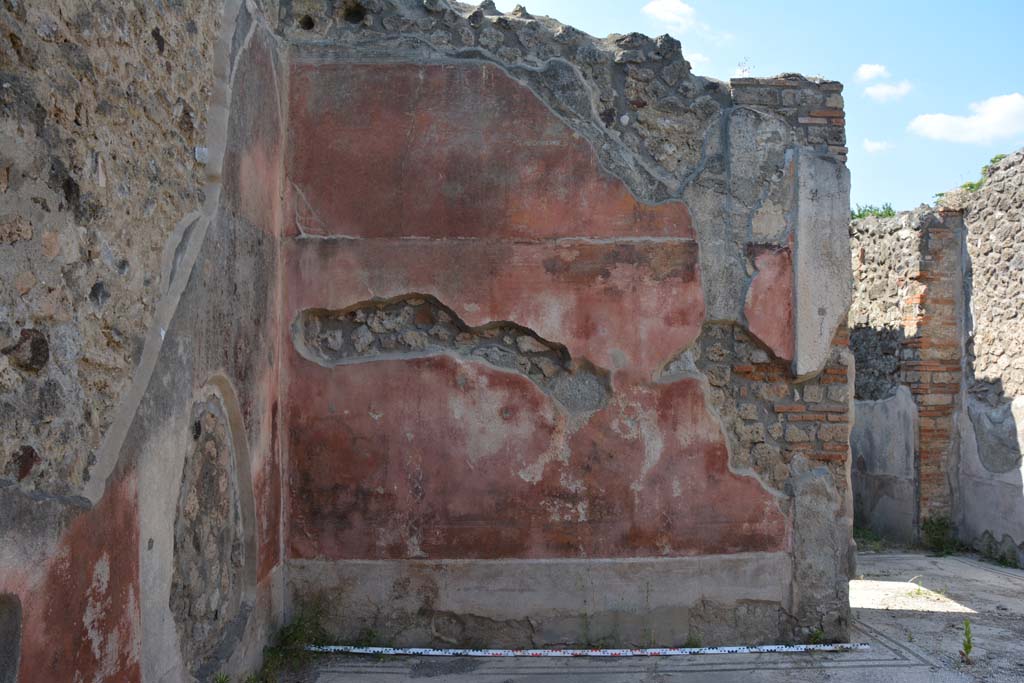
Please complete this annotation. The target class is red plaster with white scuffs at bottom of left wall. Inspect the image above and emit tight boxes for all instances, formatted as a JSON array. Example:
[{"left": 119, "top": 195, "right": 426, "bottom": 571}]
[{"left": 18, "top": 473, "right": 141, "bottom": 683}]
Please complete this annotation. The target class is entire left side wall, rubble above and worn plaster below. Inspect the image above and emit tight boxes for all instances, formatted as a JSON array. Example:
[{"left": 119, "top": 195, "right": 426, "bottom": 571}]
[{"left": 0, "top": 0, "right": 284, "bottom": 683}]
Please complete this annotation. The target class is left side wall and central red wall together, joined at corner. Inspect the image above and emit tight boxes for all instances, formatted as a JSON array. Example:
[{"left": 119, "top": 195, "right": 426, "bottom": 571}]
[{"left": 0, "top": 0, "right": 853, "bottom": 681}]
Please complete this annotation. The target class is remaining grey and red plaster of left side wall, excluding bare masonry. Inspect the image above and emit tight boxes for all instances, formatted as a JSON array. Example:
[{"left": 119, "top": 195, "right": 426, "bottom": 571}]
[{"left": 0, "top": 2, "right": 285, "bottom": 683}]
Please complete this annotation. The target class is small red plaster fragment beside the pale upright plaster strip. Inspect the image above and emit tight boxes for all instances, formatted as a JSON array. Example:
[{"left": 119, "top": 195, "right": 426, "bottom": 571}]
[{"left": 743, "top": 245, "right": 794, "bottom": 360}]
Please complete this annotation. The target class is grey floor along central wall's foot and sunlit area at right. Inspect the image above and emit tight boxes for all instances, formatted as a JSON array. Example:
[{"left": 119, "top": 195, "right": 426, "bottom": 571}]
[{"left": 289, "top": 553, "right": 1024, "bottom": 683}]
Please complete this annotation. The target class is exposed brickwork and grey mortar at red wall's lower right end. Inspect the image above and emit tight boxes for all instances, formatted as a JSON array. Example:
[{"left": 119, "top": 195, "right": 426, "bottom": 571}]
[{"left": 657, "top": 323, "right": 852, "bottom": 640}]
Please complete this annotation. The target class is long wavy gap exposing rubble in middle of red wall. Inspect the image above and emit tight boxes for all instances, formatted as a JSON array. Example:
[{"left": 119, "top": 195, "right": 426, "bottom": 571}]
[{"left": 292, "top": 294, "right": 611, "bottom": 414}]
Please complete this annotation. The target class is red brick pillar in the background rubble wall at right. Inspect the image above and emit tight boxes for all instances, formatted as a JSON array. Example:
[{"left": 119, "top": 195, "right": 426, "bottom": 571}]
[{"left": 900, "top": 212, "right": 964, "bottom": 522}]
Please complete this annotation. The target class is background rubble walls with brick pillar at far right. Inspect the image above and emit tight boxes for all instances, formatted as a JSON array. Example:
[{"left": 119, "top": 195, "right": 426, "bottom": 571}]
[{"left": 850, "top": 152, "right": 1024, "bottom": 563}]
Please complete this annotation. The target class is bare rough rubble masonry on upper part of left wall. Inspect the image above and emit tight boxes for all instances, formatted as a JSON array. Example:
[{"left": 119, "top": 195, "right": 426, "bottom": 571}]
[{"left": 0, "top": 0, "right": 221, "bottom": 495}]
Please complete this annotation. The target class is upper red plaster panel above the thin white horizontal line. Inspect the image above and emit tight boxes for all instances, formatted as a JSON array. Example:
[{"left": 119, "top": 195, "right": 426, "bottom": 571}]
[{"left": 287, "top": 62, "right": 693, "bottom": 240}]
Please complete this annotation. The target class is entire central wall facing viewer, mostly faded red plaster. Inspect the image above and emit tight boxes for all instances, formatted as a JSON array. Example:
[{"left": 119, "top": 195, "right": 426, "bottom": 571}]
[{"left": 281, "top": 3, "right": 851, "bottom": 645}]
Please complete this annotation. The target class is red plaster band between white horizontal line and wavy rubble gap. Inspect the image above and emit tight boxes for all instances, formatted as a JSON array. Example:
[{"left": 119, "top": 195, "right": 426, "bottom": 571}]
[{"left": 283, "top": 240, "right": 705, "bottom": 379}]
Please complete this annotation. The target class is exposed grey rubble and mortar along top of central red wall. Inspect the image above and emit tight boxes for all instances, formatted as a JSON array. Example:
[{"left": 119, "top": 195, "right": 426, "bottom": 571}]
[{"left": 282, "top": 0, "right": 849, "bottom": 333}]
